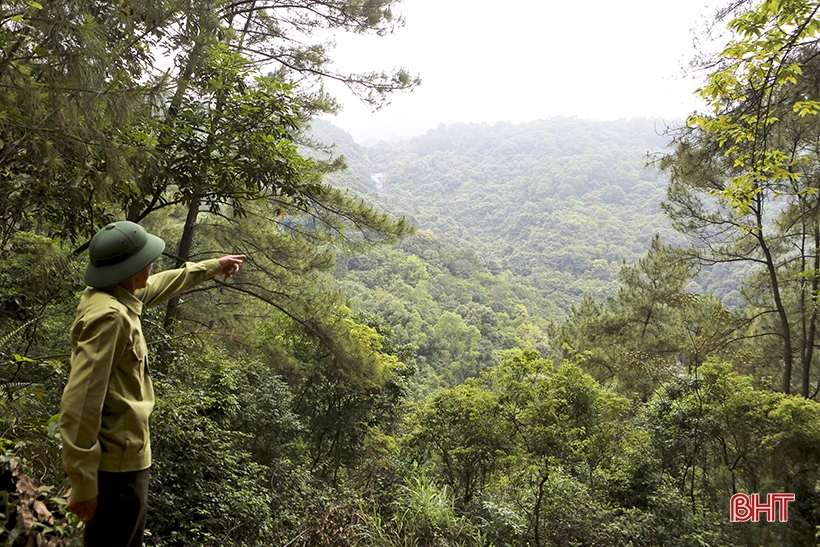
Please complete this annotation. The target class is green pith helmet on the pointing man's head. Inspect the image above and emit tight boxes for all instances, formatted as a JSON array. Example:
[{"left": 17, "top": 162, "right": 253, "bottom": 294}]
[{"left": 84, "top": 220, "right": 165, "bottom": 288}]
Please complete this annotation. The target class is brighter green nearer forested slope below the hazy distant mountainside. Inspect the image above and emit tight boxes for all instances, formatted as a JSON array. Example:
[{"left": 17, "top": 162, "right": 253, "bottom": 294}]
[{"left": 336, "top": 232, "right": 551, "bottom": 390}]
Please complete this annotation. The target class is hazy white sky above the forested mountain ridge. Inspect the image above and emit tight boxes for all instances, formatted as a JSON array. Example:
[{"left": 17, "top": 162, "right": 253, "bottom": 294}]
[{"left": 320, "top": 0, "right": 712, "bottom": 142}]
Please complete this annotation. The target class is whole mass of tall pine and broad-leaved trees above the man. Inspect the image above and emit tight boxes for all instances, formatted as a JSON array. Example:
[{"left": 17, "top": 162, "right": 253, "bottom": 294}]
[{"left": 0, "top": 0, "right": 418, "bottom": 342}]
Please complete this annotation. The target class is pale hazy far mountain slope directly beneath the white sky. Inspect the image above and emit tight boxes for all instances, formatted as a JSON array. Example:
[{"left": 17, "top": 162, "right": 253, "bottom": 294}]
[{"left": 317, "top": 118, "right": 682, "bottom": 309}]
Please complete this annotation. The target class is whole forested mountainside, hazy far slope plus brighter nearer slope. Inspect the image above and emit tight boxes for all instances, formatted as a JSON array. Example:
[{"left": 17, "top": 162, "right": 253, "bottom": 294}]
[{"left": 313, "top": 118, "right": 683, "bottom": 389}]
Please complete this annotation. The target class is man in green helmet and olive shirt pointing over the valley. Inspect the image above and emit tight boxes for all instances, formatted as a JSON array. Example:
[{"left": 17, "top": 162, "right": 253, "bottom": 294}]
[{"left": 60, "top": 222, "right": 245, "bottom": 547}]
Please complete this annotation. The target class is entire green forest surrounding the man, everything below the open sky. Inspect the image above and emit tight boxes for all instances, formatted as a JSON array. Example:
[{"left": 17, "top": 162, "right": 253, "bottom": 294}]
[{"left": 0, "top": 0, "right": 820, "bottom": 547}]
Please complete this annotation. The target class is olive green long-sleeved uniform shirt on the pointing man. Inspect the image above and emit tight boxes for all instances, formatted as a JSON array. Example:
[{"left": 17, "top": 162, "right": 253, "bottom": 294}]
[{"left": 60, "top": 259, "right": 221, "bottom": 501}]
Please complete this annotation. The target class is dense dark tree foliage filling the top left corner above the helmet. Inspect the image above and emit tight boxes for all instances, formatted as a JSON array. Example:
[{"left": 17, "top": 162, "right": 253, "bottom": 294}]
[{"left": 0, "top": 0, "right": 172, "bottom": 242}]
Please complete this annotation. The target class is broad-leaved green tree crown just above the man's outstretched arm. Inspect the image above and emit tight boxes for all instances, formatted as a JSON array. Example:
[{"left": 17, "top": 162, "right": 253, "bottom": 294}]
[{"left": 138, "top": 44, "right": 318, "bottom": 223}]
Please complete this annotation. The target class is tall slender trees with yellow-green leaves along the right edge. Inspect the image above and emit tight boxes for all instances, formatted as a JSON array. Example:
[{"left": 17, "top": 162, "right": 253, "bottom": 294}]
[{"left": 661, "top": 0, "right": 820, "bottom": 396}]
